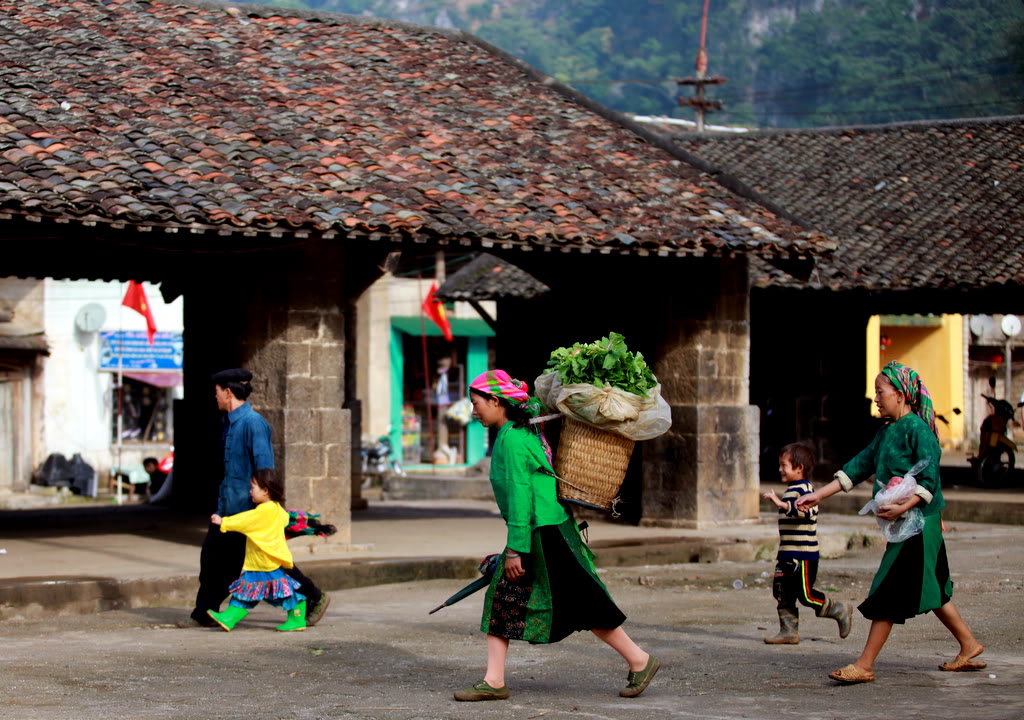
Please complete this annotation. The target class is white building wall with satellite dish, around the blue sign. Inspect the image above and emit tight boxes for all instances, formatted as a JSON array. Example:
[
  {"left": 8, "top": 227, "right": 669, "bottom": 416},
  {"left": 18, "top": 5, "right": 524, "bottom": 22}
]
[{"left": 36, "top": 279, "right": 182, "bottom": 478}]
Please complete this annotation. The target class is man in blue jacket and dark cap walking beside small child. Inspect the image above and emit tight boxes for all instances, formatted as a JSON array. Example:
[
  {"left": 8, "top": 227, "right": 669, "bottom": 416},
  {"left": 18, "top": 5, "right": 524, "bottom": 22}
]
[{"left": 190, "top": 368, "right": 331, "bottom": 627}]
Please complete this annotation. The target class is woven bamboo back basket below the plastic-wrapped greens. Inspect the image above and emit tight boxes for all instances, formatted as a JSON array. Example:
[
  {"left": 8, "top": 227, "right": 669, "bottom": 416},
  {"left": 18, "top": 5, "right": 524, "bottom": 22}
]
[{"left": 555, "top": 417, "right": 636, "bottom": 513}]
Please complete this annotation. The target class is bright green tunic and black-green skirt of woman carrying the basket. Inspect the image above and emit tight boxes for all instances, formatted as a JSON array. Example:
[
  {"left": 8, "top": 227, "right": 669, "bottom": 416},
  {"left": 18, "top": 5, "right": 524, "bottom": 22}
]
[{"left": 480, "top": 422, "right": 625, "bottom": 642}]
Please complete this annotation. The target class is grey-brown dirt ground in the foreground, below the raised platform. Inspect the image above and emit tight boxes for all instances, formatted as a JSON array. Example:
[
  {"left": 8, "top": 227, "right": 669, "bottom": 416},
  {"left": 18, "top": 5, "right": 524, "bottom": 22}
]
[{"left": 0, "top": 523, "right": 1024, "bottom": 720}]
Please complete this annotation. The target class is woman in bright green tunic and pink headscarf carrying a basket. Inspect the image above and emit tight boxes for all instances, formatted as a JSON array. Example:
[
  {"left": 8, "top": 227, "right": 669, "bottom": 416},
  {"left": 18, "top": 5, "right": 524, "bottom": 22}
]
[{"left": 455, "top": 370, "right": 660, "bottom": 701}]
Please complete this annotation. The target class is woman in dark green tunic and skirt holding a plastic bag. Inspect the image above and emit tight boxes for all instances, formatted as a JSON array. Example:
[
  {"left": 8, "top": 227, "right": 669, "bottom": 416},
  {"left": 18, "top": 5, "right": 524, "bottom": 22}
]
[{"left": 797, "top": 362, "right": 986, "bottom": 684}]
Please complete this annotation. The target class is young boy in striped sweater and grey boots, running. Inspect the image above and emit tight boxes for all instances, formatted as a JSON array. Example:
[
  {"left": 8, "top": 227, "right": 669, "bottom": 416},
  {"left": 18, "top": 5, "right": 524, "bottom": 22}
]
[{"left": 762, "top": 442, "right": 853, "bottom": 645}]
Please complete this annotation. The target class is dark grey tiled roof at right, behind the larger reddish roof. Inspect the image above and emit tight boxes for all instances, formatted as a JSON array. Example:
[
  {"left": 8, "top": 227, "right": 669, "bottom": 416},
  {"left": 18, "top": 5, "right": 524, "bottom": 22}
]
[{"left": 676, "top": 117, "right": 1024, "bottom": 290}]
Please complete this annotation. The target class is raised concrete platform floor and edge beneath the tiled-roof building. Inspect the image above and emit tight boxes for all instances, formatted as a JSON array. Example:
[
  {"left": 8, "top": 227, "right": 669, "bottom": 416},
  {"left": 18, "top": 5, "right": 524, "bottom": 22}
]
[{"left": 0, "top": 486, "right": 1024, "bottom": 621}]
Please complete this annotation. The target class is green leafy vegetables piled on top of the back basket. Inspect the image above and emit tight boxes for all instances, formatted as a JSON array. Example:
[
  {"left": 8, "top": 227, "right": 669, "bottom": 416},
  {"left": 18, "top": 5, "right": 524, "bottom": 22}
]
[{"left": 545, "top": 333, "right": 657, "bottom": 395}]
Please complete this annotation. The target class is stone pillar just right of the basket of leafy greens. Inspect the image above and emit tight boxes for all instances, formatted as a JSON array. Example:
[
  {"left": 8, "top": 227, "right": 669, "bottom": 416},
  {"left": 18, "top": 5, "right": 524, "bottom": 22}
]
[{"left": 638, "top": 258, "right": 759, "bottom": 528}]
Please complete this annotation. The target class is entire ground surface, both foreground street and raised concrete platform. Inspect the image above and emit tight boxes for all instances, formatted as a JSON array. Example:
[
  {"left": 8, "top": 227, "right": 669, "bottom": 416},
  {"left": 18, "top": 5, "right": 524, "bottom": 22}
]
[{"left": 0, "top": 490, "right": 1024, "bottom": 720}]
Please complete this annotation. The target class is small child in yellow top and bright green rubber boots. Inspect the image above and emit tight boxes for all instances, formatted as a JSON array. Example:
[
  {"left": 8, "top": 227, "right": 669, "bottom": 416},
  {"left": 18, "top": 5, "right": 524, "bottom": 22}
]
[{"left": 207, "top": 470, "right": 306, "bottom": 632}]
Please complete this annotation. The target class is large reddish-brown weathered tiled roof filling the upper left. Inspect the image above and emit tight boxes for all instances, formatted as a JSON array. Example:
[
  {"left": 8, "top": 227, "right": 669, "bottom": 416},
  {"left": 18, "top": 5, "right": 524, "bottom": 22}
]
[{"left": 0, "top": 0, "right": 830, "bottom": 257}]
